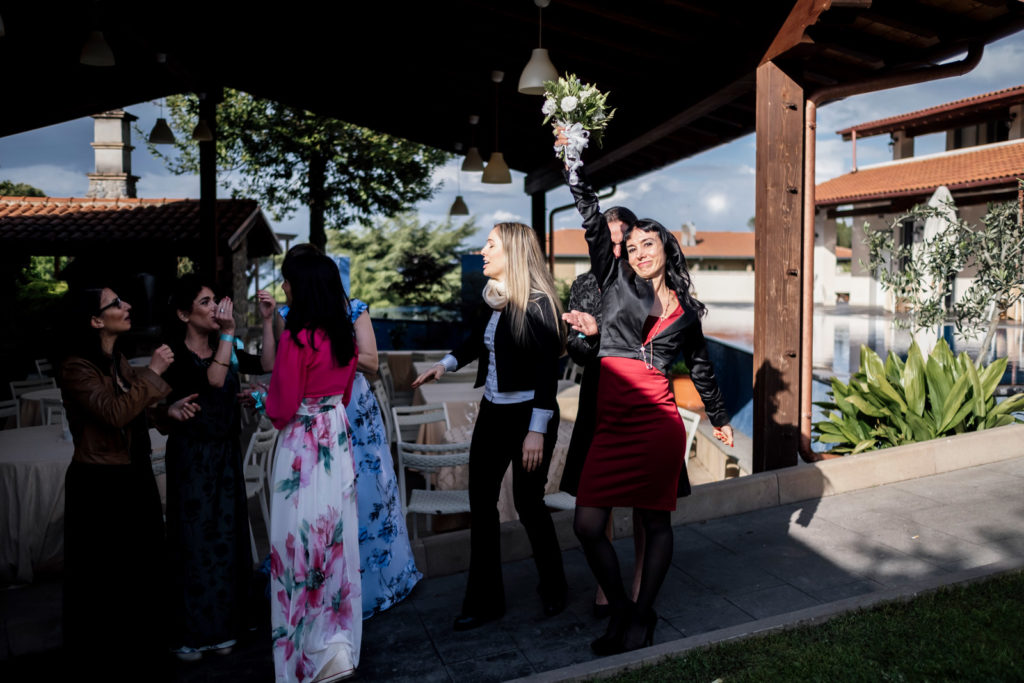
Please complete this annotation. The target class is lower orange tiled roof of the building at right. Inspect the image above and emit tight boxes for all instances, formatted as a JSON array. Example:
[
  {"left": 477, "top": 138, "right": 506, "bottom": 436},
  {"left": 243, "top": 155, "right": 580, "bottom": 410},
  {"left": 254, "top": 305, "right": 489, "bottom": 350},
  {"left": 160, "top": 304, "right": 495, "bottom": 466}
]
[{"left": 814, "top": 140, "right": 1024, "bottom": 206}]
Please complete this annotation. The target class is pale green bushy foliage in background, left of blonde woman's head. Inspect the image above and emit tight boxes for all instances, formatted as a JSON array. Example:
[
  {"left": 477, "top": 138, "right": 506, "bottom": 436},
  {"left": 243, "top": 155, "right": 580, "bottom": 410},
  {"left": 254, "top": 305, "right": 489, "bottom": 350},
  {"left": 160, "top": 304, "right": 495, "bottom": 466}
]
[{"left": 330, "top": 212, "right": 477, "bottom": 308}]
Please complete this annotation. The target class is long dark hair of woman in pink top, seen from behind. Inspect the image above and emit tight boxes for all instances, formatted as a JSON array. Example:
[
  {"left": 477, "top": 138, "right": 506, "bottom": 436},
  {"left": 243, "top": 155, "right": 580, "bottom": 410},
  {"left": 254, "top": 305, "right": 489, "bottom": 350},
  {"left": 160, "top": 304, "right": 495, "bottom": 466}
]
[{"left": 281, "top": 250, "right": 355, "bottom": 368}]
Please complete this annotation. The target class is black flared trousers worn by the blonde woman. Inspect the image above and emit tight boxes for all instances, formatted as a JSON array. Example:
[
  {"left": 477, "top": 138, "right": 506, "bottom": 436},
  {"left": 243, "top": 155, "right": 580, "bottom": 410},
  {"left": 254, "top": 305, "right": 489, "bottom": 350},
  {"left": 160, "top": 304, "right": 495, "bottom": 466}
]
[{"left": 462, "top": 399, "right": 566, "bottom": 616}]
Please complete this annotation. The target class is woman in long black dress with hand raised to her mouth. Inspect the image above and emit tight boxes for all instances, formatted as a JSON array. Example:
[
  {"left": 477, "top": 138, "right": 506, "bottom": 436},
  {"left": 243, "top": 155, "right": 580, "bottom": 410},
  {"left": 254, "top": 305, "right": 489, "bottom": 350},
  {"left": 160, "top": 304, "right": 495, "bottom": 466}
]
[{"left": 165, "top": 274, "right": 275, "bottom": 661}]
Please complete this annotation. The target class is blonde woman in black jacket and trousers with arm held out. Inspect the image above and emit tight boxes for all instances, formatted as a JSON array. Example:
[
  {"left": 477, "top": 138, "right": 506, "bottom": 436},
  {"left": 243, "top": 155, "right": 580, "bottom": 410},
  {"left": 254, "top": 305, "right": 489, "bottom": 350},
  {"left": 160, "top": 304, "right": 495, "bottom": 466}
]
[{"left": 413, "top": 223, "right": 566, "bottom": 631}]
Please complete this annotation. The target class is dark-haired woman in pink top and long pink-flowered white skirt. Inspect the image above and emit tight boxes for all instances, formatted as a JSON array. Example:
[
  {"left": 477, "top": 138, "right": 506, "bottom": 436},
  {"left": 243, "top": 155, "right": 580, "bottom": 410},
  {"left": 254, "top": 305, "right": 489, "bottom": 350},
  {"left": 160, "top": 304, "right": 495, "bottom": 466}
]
[{"left": 266, "top": 253, "right": 362, "bottom": 683}]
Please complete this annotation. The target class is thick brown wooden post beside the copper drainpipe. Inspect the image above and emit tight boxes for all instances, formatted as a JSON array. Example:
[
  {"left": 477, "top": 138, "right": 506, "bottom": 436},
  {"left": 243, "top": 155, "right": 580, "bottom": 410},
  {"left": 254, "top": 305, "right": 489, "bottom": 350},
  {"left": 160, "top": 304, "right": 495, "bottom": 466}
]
[{"left": 754, "top": 61, "right": 811, "bottom": 472}]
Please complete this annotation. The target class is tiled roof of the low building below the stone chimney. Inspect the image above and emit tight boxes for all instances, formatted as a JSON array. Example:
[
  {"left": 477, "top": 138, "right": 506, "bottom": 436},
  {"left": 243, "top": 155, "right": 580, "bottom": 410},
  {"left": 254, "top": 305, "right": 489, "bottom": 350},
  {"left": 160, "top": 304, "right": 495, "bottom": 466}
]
[{"left": 0, "top": 197, "right": 281, "bottom": 256}]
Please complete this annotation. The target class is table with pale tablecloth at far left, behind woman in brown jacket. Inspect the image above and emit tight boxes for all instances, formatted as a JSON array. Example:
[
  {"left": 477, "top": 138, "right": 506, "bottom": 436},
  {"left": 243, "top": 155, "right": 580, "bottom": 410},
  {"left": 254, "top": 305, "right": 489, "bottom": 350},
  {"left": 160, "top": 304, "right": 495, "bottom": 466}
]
[{"left": 0, "top": 425, "right": 167, "bottom": 583}]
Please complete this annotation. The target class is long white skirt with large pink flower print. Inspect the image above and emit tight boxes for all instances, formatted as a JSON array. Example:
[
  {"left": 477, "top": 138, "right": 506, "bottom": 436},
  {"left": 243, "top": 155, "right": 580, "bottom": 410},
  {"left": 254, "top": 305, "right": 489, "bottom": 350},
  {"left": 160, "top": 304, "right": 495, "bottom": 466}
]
[{"left": 270, "top": 395, "right": 362, "bottom": 683}]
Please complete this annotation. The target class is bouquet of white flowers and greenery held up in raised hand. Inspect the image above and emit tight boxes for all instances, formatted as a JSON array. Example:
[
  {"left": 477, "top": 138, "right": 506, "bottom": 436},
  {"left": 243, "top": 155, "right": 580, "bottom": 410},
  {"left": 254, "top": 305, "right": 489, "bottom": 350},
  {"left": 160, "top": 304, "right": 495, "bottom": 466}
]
[{"left": 541, "top": 74, "right": 615, "bottom": 185}]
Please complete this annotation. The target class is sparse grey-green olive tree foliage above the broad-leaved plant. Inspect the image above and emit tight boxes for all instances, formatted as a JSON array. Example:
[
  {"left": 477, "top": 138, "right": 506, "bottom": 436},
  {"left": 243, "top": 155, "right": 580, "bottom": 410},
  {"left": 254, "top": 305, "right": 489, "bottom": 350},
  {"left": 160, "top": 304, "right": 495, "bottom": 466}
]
[{"left": 864, "top": 189, "right": 1024, "bottom": 364}]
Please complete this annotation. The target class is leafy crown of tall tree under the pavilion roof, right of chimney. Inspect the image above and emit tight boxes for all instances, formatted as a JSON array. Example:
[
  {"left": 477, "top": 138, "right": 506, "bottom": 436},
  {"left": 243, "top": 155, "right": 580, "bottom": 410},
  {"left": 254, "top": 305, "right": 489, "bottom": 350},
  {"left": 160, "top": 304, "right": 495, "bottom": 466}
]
[{"left": 148, "top": 89, "right": 449, "bottom": 248}]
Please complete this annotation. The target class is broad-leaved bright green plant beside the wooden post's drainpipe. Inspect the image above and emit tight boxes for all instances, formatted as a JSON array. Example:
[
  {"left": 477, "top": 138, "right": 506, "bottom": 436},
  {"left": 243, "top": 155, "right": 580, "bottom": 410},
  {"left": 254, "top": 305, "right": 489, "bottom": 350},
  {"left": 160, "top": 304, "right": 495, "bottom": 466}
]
[{"left": 814, "top": 340, "right": 1024, "bottom": 455}]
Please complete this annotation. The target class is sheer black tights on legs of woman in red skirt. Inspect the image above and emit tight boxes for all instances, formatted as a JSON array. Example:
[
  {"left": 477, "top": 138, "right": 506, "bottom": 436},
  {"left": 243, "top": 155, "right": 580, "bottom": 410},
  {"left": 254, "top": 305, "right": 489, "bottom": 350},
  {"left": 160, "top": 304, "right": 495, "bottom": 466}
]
[{"left": 572, "top": 506, "right": 674, "bottom": 613}]
